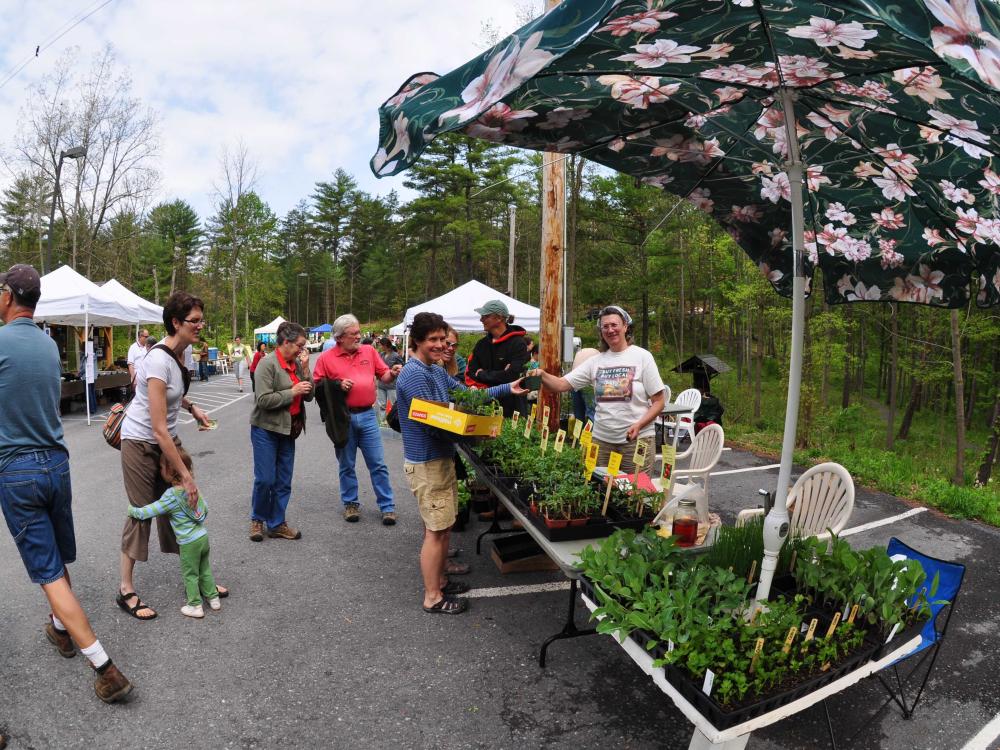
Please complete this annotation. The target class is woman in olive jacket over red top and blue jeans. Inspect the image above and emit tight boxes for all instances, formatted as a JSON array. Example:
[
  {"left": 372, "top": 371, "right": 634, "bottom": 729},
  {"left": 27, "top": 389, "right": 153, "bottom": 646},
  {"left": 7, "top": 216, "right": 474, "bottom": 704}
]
[{"left": 250, "top": 321, "right": 313, "bottom": 542}]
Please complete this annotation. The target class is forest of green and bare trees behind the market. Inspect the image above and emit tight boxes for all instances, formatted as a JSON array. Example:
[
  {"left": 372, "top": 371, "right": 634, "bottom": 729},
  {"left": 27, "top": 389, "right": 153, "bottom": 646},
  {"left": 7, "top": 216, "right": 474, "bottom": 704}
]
[{"left": 0, "top": 48, "right": 1000, "bottom": 525}]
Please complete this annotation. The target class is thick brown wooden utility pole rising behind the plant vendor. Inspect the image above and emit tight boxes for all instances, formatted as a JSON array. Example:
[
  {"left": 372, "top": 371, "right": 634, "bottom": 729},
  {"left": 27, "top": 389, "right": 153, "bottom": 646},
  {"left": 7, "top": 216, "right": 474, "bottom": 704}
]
[{"left": 538, "top": 0, "right": 566, "bottom": 433}]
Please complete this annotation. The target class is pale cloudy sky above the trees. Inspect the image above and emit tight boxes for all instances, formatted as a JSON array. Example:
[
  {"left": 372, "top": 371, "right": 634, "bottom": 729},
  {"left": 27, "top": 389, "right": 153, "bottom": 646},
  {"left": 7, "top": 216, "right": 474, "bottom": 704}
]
[{"left": 0, "top": 0, "right": 542, "bottom": 222}]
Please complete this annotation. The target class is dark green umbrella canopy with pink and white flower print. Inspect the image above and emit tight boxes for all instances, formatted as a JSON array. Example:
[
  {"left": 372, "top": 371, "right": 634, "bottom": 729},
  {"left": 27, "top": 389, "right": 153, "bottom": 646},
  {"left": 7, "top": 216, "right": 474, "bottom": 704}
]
[{"left": 371, "top": 0, "right": 1000, "bottom": 307}]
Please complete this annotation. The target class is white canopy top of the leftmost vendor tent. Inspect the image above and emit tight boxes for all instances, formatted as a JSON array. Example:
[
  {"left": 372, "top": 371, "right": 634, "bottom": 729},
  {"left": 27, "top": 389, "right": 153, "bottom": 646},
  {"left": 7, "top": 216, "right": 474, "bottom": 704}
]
[{"left": 34, "top": 266, "right": 141, "bottom": 326}]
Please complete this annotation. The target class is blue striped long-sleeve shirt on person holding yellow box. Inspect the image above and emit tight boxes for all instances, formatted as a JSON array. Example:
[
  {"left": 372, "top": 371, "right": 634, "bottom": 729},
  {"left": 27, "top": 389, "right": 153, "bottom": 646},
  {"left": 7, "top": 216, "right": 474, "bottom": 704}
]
[{"left": 396, "top": 357, "right": 510, "bottom": 464}]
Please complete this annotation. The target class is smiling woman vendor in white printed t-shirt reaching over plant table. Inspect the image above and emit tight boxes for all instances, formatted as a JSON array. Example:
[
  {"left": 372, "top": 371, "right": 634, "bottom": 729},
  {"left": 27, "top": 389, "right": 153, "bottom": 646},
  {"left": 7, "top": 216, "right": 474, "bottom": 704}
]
[{"left": 538, "top": 305, "right": 664, "bottom": 473}]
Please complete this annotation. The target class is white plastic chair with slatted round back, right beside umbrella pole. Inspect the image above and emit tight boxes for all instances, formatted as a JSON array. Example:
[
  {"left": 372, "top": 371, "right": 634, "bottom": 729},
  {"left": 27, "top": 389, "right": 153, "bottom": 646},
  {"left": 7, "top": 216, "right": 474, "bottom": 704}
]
[{"left": 736, "top": 463, "right": 854, "bottom": 540}]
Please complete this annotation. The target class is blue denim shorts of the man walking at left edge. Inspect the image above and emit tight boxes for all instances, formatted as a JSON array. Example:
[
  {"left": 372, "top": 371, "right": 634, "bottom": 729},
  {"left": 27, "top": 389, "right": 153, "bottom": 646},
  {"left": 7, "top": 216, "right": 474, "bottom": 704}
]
[{"left": 0, "top": 450, "right": 76, "bottom": 585}]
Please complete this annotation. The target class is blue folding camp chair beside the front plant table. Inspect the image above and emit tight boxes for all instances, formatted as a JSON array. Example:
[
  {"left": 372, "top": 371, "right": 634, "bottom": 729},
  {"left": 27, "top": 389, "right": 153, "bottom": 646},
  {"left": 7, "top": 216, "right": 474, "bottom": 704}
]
[{"left": 875, "top": 537, "right": 965, "bottom": 719}]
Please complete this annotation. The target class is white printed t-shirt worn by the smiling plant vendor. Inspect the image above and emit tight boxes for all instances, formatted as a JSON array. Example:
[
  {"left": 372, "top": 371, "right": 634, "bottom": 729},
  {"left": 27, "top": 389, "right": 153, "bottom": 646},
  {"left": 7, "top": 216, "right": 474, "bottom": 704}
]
[{"left": 564, "top": 346, "right": 663, "bottom": 443}]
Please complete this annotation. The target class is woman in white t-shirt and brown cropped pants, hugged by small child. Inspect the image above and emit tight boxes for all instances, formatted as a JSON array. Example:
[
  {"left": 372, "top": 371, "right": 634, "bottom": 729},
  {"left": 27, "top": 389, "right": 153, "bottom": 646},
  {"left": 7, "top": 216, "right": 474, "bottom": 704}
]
[{"left": 116, "top": 292, "right": 219, "bottom": 620}]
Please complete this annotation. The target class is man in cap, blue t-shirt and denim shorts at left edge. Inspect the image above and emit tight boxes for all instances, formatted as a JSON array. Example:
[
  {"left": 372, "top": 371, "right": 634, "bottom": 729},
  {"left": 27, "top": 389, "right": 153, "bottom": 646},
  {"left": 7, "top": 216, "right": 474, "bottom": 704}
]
[{"left": 0, "top": 264, "right": 132, "bottom": 703}]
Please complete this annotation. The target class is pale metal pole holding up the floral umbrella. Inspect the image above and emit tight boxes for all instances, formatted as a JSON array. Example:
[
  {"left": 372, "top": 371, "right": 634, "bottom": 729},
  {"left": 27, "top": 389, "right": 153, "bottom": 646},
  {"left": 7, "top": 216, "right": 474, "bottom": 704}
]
[{"left": 756, "top": 89, "right": 806, "bottom": 602}]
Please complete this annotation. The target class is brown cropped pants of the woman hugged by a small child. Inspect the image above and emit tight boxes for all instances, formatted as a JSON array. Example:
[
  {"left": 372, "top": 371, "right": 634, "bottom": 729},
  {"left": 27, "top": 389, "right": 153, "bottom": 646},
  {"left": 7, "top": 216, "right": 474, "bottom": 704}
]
[{"left": 122, "top": 436, "right": 181, "bottom": 562}]
